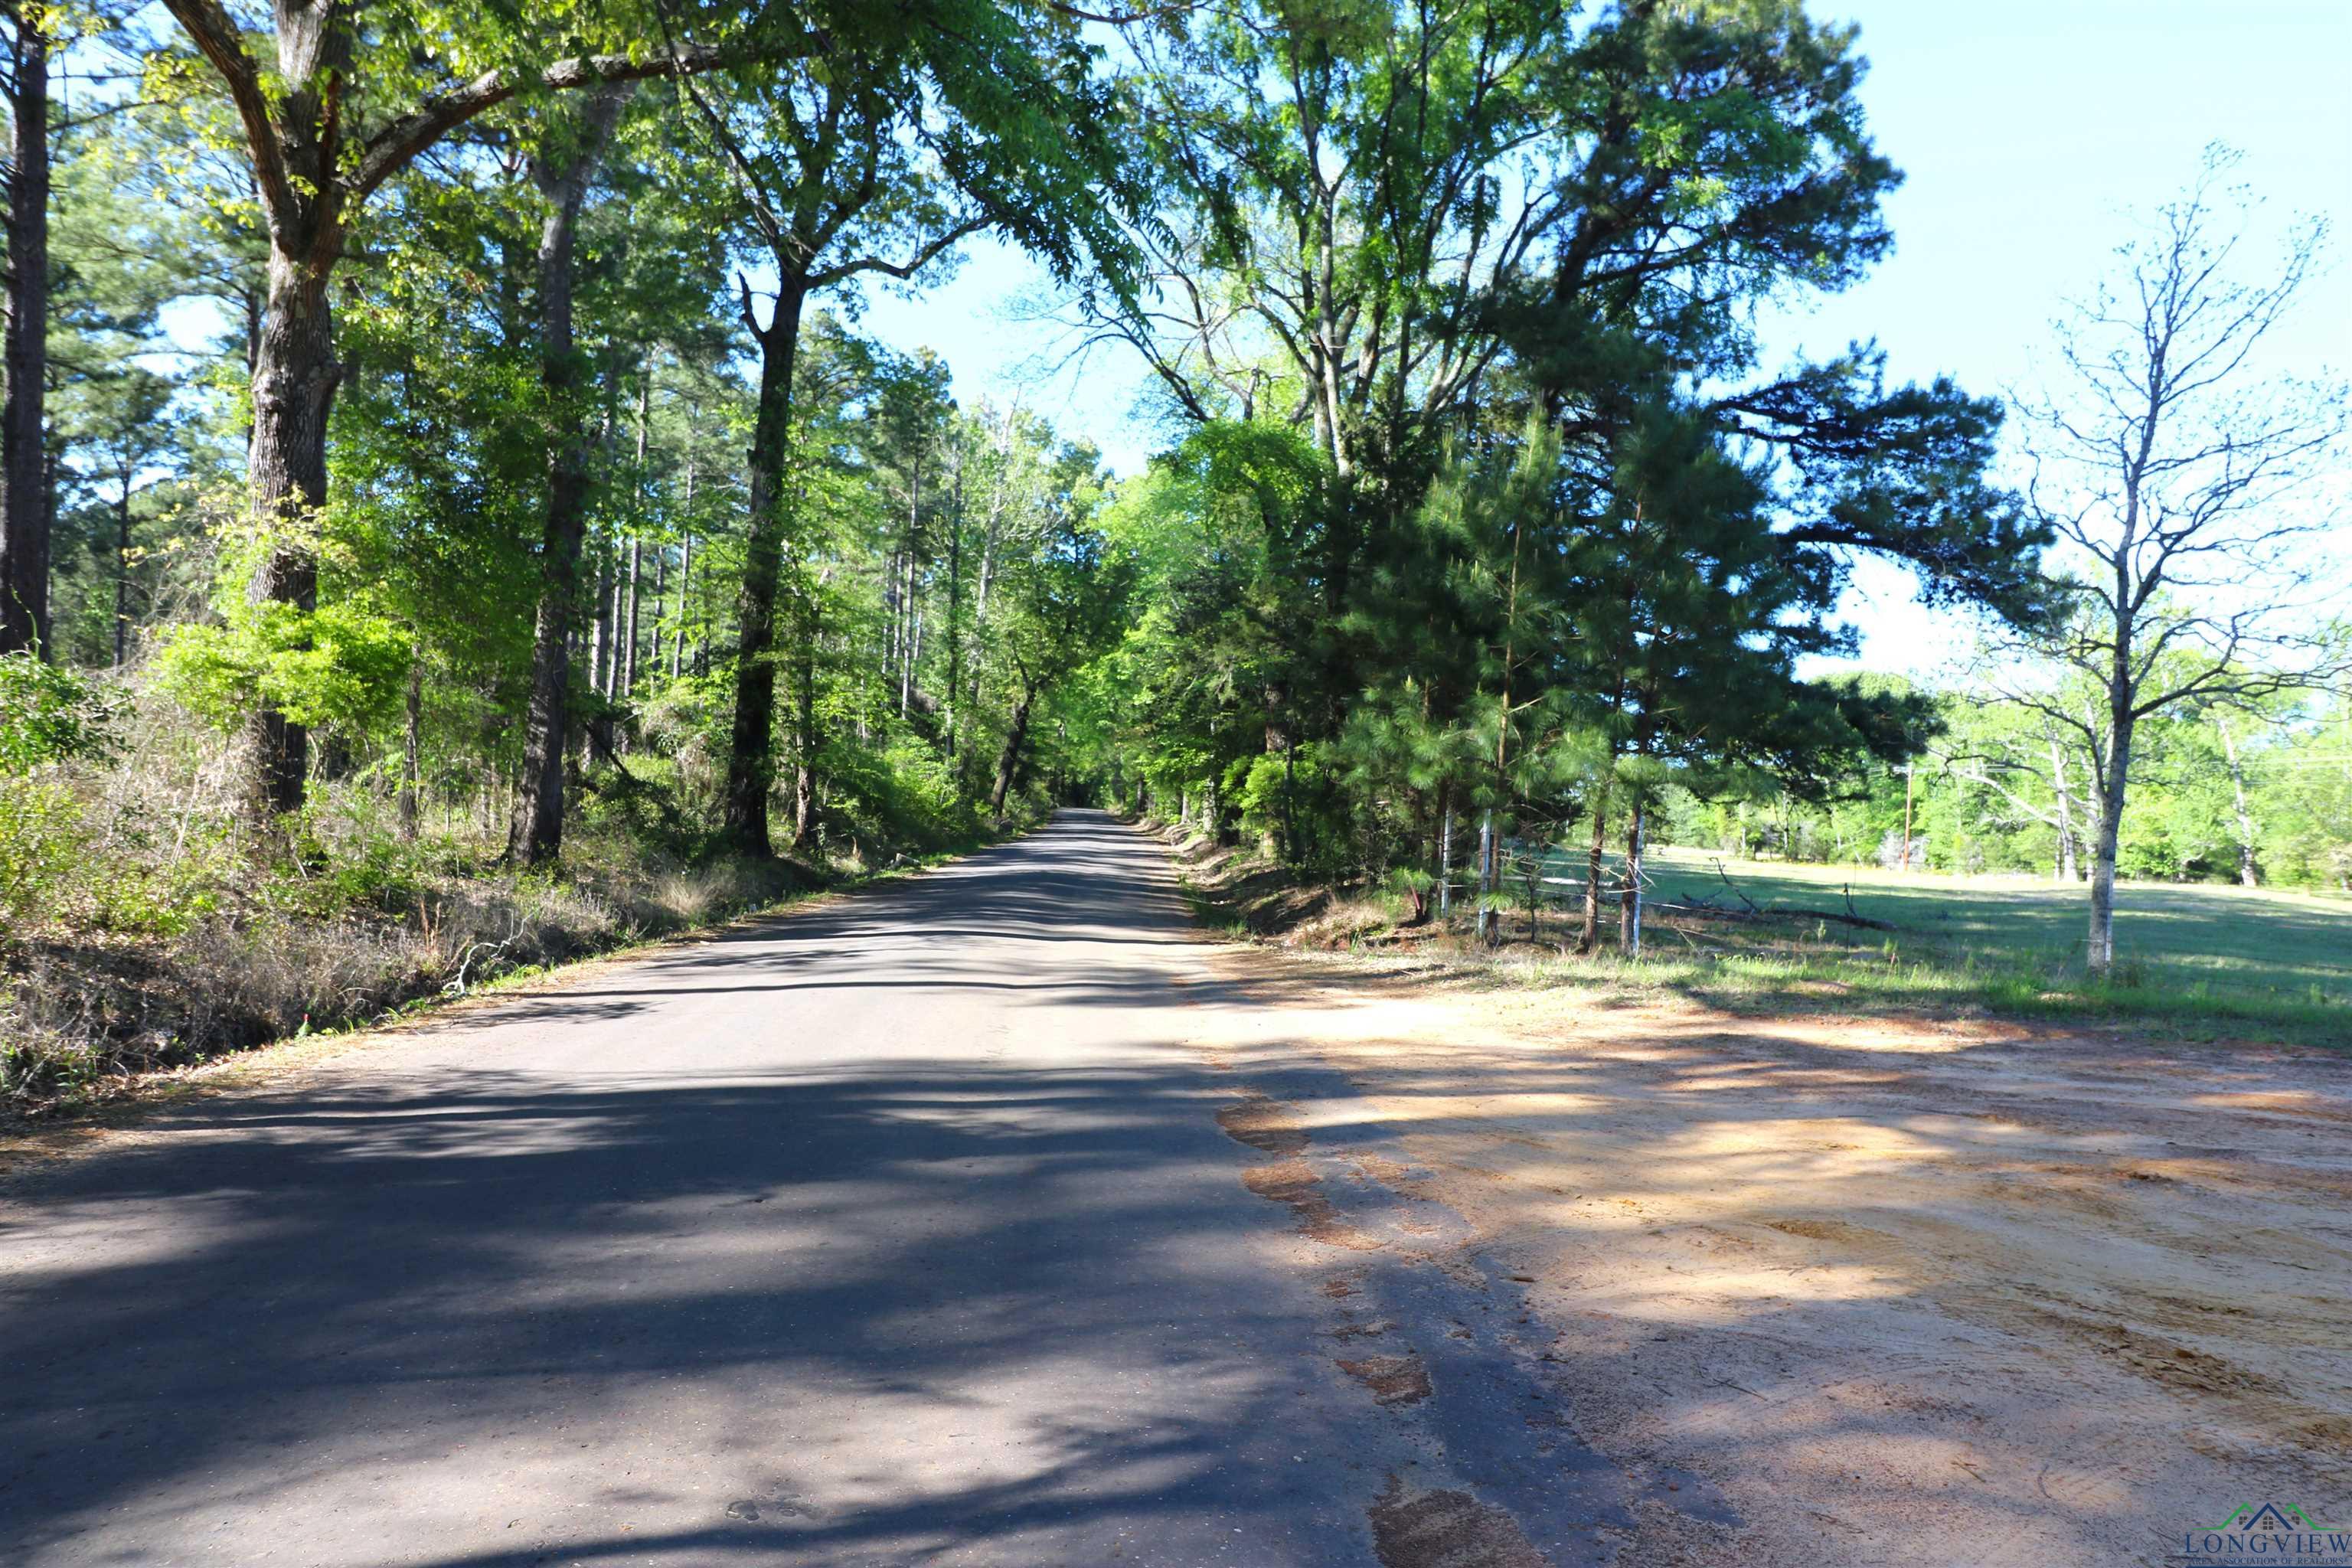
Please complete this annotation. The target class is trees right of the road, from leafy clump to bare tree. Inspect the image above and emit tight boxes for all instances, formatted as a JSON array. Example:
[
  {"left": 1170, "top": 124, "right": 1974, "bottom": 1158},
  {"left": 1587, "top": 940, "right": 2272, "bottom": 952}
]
[{"left": 1058, "top": 18, "right": 2352, "bottom": 973}]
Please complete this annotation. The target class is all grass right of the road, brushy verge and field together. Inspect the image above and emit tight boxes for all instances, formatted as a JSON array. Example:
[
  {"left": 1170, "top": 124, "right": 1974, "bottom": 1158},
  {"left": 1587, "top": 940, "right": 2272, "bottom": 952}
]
[{"left": 1187, "top": 822, "right": 2352, "bottom": 1048}]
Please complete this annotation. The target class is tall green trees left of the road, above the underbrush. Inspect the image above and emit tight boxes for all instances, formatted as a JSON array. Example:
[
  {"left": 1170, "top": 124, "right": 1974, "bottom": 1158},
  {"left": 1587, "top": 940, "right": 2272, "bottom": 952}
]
[{"left": 0, "top": 0, "right": 1126, "bottom": 884}]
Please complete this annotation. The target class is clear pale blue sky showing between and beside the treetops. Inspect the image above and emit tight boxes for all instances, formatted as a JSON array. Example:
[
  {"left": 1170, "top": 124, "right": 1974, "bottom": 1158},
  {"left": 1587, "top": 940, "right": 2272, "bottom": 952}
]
[{"left": 865, "top": 0, "right": 2352, "bottom": 670}]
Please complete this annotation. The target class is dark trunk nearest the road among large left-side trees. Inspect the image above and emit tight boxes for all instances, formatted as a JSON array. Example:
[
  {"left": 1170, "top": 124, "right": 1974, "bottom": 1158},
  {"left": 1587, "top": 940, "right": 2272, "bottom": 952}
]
[{"left": 727, "top": 277, "right": 807, "bottom": 858}]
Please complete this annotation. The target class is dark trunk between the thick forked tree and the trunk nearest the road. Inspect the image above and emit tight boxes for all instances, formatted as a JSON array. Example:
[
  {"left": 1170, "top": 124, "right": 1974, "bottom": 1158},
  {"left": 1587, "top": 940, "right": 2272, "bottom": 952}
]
[{"left": 505, "top": 90, "right": 628, "bottom": 865}]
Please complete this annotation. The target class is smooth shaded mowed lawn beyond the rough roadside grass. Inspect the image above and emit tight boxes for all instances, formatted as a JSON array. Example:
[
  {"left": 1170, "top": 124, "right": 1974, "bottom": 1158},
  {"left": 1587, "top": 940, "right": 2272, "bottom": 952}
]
[{"left": 1648, "top": 848, "right": 2352, "bottom": 1004}]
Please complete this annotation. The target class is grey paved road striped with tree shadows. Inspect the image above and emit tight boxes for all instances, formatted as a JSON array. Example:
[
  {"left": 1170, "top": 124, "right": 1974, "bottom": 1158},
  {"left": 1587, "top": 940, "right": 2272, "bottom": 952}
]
[{"left": 0, "top": 813, "right": 1655, "bottom": 1568}]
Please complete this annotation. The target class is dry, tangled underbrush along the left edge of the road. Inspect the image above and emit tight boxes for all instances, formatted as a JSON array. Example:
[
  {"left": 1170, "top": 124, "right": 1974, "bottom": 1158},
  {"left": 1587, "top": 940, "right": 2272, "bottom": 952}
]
[{"left": 0, "top": 672, "right": 1011, "bottom": 1114}]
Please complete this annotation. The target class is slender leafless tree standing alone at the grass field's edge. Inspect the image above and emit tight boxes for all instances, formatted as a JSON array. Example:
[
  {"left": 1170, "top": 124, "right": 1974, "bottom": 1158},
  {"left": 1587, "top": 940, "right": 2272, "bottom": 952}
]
[{"left": 1994, "top": 151, "right": 2352, "bottom": 971}]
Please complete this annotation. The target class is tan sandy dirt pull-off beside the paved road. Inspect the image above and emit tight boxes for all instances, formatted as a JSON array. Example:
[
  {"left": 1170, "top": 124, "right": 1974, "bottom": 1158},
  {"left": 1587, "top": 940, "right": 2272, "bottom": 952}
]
[{"left": 1200, "top": 955, "right": 2352, "bottom": 1568}]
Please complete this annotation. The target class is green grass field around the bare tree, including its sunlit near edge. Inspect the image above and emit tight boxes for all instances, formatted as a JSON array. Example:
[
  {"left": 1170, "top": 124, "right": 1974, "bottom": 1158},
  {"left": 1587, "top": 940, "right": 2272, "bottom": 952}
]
[{"left": 1495, "top": 848, "right": 2352, "bottom": 1046}]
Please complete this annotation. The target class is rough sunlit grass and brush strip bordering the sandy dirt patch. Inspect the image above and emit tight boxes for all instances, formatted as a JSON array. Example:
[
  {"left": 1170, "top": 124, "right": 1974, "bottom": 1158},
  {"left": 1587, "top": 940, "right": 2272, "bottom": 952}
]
[{"left": 1165, "top": 830, "right": 2352, "bottom": 1048}]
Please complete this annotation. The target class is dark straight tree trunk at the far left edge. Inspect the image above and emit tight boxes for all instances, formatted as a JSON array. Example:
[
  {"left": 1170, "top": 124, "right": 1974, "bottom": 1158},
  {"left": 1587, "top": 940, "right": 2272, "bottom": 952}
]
[{"left": 0, "top": 5, "right": 47, "bottom": 663}]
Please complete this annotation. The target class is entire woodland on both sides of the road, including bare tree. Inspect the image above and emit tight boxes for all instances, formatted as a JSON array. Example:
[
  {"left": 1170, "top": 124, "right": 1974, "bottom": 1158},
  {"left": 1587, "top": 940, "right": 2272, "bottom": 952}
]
[{"left": 0, "top": 0, "right": 2352, "bottom": 1096}]
